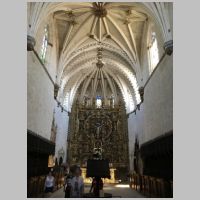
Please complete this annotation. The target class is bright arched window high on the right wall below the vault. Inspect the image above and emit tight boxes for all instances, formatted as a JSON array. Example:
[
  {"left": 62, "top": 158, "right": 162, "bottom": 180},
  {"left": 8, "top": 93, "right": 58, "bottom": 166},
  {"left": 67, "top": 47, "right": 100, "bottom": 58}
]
[{"left": 149, "top": 32, "right": 159, "bottom": 73}]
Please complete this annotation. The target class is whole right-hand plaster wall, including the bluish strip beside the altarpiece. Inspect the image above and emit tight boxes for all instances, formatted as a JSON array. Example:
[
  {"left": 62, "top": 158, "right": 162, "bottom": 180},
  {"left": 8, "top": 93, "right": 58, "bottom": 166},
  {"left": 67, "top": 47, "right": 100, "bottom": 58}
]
[{"left": 128, "top": 56, "right": 173, "bottom": 171}]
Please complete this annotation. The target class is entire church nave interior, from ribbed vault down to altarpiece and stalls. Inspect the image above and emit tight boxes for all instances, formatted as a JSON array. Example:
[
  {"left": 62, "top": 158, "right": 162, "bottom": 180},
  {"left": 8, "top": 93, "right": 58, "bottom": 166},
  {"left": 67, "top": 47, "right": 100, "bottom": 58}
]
[{"left": 27, "top": 2, "right": 173, "bottom": 198}]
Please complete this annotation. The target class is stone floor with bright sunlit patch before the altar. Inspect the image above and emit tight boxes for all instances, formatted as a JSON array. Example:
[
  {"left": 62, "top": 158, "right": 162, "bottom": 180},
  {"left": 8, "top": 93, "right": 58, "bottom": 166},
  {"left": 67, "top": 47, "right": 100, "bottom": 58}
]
[{"left": 50, "top": 184, "right": 144, "bottom": 198}]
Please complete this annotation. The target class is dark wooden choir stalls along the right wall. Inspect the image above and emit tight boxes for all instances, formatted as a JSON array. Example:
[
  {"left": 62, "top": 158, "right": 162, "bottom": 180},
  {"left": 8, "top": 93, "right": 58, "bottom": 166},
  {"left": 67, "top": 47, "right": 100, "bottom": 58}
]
[{"left": 130, "top": 131, "right": 173, "bottom": 198}]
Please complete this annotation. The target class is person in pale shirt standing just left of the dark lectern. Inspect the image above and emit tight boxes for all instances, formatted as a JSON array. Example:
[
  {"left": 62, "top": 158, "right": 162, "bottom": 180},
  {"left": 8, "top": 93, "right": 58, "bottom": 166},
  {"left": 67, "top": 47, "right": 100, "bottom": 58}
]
[{"left": 71, "top": 167, "right": 84, "bottom": 198}]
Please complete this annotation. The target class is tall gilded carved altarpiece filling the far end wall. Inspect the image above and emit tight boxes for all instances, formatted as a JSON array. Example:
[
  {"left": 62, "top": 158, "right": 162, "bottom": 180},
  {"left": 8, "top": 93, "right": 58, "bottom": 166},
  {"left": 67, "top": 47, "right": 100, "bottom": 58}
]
[{"left": 68, "top": 103, "right": 129, "bottom": 179}]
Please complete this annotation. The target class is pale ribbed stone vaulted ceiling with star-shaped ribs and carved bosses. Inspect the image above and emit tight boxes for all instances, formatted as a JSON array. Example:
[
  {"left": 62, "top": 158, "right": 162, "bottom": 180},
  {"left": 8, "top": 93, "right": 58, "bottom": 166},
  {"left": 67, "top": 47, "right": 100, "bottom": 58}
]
[{"left": 27, "top": 2, "right": 173, "bottom": 112}]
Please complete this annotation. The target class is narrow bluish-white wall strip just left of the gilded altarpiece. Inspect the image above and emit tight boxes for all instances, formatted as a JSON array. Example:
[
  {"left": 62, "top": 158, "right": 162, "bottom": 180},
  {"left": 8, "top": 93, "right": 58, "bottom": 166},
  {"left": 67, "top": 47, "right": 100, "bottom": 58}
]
[{"left": 54, "top": 101, "right": 69, "bottom": 162}]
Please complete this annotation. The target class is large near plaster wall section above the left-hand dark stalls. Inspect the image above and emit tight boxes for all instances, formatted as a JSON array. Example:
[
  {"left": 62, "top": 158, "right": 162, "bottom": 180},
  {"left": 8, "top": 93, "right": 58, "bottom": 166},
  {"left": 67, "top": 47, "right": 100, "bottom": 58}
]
[{"left": 27, "top": 52, "right": 54, "bottom": 139}]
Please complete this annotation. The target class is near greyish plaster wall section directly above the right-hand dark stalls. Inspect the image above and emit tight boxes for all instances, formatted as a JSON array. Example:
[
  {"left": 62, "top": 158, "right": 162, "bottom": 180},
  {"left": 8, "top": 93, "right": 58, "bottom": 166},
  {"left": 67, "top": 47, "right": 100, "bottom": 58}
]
[{"left": 142, "top": 56, "right": 173, "bottom": 142}]
